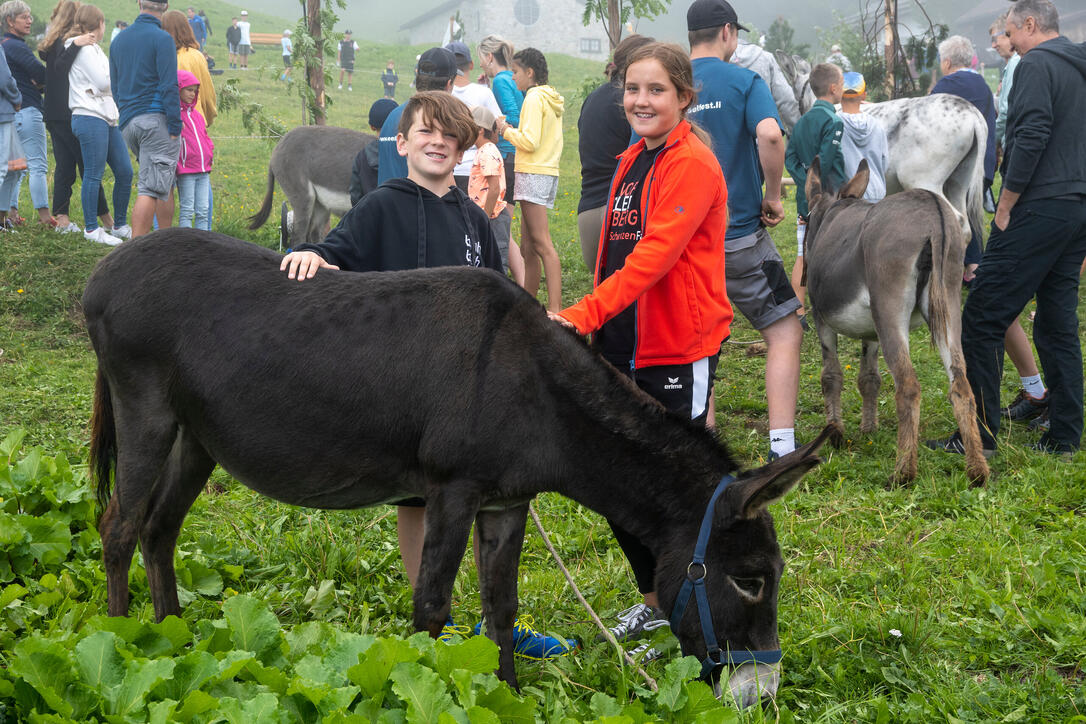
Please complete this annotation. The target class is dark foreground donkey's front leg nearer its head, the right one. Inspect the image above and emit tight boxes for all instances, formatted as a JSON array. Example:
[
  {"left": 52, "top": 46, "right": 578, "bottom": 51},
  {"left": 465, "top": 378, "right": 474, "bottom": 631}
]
[{"left": 476, "top": 505, "right": 528, "bottom": 688}]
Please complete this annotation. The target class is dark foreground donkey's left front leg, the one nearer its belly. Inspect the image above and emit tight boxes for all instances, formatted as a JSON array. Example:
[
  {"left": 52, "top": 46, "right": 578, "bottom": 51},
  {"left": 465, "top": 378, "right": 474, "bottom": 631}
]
[{"left": 414, "top": 482, "right": 479, "bottom": 638}]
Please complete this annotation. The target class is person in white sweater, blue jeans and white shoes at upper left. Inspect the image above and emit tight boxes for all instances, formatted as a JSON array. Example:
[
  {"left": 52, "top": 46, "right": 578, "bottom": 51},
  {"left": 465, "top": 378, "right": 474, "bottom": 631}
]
[{"left": 64, "top": 5, "right": 132, "bottom": 246}]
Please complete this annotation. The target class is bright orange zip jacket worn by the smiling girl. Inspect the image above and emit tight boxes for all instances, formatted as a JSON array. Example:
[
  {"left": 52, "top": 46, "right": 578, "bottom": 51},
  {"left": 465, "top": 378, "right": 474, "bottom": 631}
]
[{"left": 559, "top": 120, "right": 732, "bottom": 368}]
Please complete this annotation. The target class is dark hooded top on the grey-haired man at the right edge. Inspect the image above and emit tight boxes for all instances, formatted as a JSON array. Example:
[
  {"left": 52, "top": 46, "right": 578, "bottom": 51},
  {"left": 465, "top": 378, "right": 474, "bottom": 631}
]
[{"left": 1001, "top": 36, "right": 1086, "bottom": 203}]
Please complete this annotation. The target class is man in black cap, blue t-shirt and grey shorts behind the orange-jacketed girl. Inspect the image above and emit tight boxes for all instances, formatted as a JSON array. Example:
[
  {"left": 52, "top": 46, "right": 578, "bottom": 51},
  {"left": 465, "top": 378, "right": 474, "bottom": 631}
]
[{"left": 686, "top": 0, "right": 804, "bottom": 459}]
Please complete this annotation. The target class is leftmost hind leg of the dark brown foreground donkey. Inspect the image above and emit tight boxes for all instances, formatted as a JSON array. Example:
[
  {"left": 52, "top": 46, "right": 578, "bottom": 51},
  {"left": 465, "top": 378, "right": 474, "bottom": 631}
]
[{"left": 98, "top": 401, "right": 177, "bottom": 615}]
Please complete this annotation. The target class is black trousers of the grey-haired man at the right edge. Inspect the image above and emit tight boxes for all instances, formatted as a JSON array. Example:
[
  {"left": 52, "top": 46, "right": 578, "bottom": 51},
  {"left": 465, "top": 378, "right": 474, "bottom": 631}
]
[{"left": 961, "top": 195, "right": 1086, "bottom": 447}]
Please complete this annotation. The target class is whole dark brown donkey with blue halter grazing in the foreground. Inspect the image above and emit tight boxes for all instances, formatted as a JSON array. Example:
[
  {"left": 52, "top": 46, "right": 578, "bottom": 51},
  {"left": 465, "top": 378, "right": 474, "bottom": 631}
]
[{"left": 83, "top": 229, "right": 824, "bottom": 701}]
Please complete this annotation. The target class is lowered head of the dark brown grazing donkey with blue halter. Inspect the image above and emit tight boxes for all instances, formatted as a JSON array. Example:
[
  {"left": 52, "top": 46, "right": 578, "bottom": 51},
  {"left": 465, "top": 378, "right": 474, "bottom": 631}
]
[{"left": 656, "top": 429, "right": 829, "bottom": 707}]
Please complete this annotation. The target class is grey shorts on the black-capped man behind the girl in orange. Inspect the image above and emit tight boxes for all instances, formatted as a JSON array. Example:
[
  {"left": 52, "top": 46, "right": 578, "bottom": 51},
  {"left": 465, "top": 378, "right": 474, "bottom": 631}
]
[{"left": 724, "top": 228, "right": 800, "bottom": 329}]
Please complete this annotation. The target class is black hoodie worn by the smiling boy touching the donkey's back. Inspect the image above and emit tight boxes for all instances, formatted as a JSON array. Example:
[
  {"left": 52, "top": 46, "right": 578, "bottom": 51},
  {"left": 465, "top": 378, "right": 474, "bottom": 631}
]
[{"left": 294, "top": 178, "right": 502, "bottom": 272}]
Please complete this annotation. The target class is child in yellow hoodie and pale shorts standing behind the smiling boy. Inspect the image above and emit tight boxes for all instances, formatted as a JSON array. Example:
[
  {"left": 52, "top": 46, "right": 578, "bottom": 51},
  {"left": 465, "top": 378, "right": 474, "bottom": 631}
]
[{"left": 497, "top": 48, "right": 565, "bottom": 312}]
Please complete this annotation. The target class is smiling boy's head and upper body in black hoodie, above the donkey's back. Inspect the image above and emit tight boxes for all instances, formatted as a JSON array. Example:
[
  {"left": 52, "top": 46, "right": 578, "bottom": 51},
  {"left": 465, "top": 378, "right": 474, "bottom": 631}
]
[{"left": 279, "top": 91, "right": 502, "bottom": 281}]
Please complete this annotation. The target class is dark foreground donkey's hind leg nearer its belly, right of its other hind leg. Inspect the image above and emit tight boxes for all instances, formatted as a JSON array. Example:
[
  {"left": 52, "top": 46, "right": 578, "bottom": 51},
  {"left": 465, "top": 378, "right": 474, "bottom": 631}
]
[{"left": 139, "top": 428, "right": 215, "bottom": 621}]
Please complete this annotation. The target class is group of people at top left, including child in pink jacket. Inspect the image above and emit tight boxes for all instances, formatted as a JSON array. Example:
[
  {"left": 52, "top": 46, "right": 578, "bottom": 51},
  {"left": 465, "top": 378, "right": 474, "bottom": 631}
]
[{"left": 0, "top": 0, "right": 217, "bottom": 245}]
